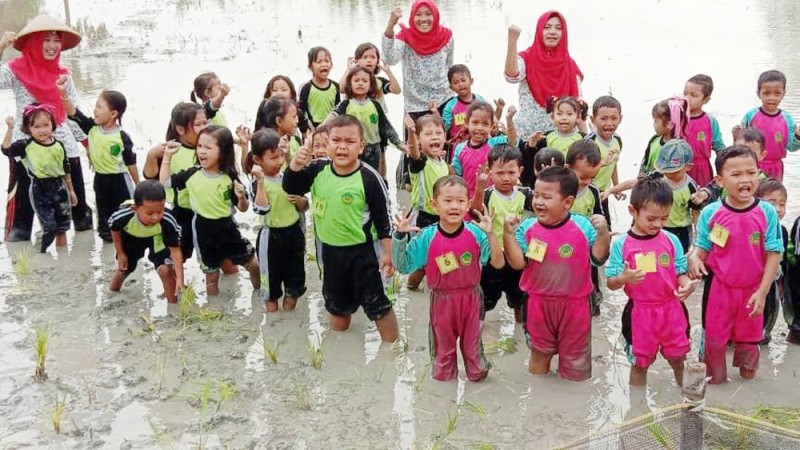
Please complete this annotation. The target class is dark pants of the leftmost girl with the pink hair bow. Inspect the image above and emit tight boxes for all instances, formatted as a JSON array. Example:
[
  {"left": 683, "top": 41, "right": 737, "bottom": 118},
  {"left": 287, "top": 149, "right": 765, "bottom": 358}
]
[{"left": 30, "top": 177, "right": 70, "bottom": 253}]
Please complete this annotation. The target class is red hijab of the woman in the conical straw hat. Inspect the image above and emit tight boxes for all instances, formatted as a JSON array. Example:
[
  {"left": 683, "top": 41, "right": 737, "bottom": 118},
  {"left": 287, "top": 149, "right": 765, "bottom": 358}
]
[{"left": 8, "top": 31, "right": 69, "bottom": 124}]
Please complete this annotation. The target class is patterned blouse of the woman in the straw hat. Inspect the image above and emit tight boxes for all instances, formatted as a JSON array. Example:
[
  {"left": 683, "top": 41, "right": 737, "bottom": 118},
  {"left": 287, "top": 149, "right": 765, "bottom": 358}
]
[{"left": 0, "top": 64, "right": 84, "bottom": 158}]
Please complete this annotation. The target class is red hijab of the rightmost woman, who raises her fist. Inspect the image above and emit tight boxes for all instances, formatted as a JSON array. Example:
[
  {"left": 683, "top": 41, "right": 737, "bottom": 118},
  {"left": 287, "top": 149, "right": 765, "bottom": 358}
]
[{"left": 519, "top": 11, "right": 583, "bottom": 106}]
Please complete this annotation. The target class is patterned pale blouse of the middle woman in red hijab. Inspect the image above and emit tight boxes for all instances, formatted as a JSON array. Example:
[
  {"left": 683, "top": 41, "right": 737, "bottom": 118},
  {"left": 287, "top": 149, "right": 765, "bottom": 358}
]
[{"left": 382, "top": 36, "right": 455, "bottom": 113}]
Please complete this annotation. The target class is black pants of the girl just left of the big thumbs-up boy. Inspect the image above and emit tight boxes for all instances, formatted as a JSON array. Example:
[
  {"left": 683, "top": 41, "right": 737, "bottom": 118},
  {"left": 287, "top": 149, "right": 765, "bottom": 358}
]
[{"left": 256, "top": 221, "right": 306, "bottom": 301}]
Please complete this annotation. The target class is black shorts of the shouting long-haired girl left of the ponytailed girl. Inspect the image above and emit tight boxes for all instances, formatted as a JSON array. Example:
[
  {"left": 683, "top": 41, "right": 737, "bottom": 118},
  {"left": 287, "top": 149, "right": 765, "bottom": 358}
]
[{"left": 192, "top": 215, "right": 256, "bottom": 273}]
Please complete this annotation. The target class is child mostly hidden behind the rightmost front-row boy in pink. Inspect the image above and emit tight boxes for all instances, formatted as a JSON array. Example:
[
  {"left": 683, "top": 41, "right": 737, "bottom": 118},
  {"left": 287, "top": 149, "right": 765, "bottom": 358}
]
[{"left": 756, "top": 178, "right": 794, "bottom": 345}]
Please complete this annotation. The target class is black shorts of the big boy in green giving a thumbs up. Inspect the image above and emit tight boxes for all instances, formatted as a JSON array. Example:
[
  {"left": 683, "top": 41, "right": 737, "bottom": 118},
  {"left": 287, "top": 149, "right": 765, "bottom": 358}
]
[{"left": 322, "top": 242, "right": 392, "bottom": 320}]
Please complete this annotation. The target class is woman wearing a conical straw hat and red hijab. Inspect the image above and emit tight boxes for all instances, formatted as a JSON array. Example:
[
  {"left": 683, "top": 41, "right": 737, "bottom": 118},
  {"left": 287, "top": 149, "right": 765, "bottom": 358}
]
[{"left": 0, "top": 14, "right": 92, "bottom": 241}]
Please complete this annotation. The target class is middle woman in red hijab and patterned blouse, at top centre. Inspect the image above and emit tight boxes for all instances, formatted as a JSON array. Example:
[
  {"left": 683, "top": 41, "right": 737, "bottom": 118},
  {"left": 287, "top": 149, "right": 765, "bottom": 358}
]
[{"left": 382, "top": 0, "right": 454, "bottom": 188}]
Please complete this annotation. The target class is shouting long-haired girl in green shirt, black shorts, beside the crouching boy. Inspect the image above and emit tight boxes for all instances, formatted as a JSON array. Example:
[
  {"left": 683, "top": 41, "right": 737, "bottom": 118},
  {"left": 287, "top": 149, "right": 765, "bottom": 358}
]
[{"left": 160, "top": 125, "right": 261, "bottom": 295}]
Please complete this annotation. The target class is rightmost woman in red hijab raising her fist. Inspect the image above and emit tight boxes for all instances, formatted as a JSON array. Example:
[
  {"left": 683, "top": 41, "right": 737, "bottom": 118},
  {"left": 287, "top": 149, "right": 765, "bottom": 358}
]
[{"left": 505, "top": 11, "right": 586, "bottom": 185}]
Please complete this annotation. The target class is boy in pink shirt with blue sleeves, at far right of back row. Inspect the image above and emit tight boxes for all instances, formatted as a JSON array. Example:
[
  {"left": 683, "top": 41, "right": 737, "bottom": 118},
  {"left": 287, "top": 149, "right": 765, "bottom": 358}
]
[{"left": 733, "top": 70, "right": 800, "bottom": 181}]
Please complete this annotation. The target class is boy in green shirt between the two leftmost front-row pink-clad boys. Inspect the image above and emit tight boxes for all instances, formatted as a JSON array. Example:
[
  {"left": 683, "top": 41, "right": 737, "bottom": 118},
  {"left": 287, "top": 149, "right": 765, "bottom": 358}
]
[{"left": 472, "top": 144, "right": 536, "bottom": 323}]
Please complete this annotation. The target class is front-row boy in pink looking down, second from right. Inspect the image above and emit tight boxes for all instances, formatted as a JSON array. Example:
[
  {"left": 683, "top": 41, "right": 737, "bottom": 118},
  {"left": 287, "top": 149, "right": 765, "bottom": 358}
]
[{"left": 605, "top": 174, "right": 696, "bottom": 386}]
